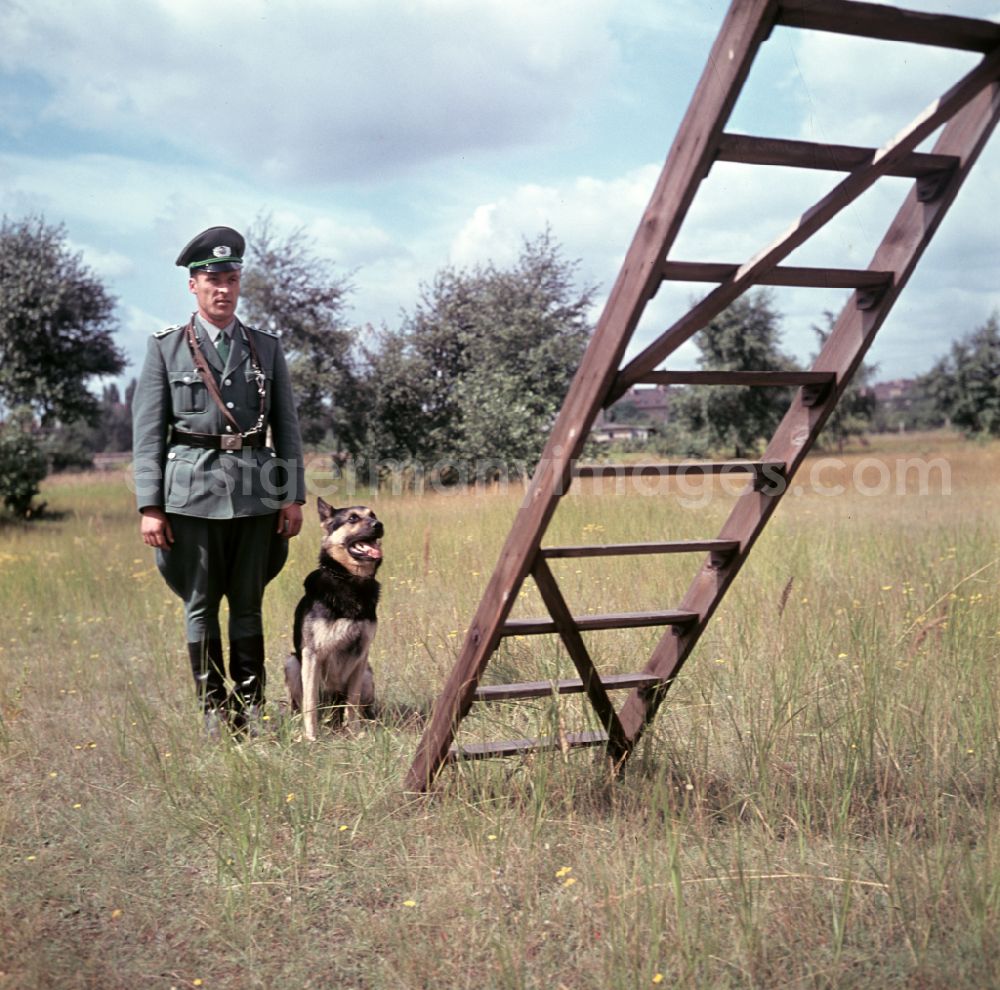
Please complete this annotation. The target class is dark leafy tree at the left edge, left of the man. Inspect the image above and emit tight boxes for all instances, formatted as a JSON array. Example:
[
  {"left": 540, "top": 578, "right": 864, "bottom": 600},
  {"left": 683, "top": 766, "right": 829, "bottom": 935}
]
[{"left": 0, "top": 216, "right": 125, "bottom": 425}]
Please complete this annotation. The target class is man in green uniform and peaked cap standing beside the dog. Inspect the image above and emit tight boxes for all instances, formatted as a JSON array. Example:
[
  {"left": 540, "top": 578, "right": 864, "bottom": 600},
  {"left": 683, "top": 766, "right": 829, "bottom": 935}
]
[{"left": 133, "top": 227, "right": 305, "bottom": 736}]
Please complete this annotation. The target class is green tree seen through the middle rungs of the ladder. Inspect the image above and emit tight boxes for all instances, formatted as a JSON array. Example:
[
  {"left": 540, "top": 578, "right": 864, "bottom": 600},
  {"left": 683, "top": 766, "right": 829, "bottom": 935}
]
[{"left": 668, "top": 289, "right": 796, "bottom": 457}]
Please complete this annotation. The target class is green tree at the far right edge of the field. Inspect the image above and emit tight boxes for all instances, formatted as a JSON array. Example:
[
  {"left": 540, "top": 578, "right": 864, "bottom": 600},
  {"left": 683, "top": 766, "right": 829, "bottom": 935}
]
[{"left": 918, "top": 312, "right": 1000, "bottom": 436}]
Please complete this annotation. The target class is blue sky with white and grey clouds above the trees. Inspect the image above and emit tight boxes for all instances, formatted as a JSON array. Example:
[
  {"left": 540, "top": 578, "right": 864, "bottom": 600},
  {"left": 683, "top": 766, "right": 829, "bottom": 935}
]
[{"left": 0, "top": 0, "right": 1000, "bottom": 392}]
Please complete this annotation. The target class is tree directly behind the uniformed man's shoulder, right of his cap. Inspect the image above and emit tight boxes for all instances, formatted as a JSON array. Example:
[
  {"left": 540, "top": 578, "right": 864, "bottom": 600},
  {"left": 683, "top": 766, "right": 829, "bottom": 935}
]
[{"left": 241, "top": 216, "right": 362, "bottom": 450}]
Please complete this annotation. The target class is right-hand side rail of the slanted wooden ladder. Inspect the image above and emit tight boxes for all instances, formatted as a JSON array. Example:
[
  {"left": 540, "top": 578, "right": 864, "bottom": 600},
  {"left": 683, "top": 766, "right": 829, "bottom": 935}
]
[{"left": 619, "top": 77, "right": 1000, "bottom": 747}]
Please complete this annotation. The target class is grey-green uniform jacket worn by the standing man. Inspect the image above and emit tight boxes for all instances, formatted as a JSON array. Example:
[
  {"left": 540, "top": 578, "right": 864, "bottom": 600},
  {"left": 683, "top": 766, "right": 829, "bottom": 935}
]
[{"left": 132, "top": 320, "right": 306, "bottom": 519}]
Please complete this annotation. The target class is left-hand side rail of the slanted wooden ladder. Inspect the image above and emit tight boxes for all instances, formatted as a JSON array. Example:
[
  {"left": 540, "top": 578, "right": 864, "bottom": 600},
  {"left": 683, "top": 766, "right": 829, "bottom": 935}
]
[{"left": 406, "top": 0, "right": 777, "bottom": 791}]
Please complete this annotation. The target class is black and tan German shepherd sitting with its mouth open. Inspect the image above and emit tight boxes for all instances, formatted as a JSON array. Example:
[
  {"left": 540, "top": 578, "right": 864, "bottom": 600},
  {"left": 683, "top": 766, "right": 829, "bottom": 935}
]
[{"left": 285, "top": 498, "right": 384, "bottom": 741}]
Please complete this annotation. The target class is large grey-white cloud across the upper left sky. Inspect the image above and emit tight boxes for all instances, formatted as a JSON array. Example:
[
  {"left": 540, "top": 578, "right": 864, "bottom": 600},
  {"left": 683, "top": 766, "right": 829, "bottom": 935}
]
[{"left": 0, "top": 0, "right": 615, "bottom": 182}]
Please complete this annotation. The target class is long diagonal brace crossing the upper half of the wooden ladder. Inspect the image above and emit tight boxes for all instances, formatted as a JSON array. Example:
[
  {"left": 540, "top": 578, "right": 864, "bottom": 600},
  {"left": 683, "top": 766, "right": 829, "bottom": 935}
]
[{"left": 608, "top": 49, "right": 1000, "bottom": 404}]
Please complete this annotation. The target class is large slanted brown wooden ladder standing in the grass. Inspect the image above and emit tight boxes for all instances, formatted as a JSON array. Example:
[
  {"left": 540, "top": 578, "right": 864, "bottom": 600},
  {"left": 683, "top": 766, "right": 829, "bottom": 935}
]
[{"left": 406, "top": 0, "right": 1000, "bottom": 791}]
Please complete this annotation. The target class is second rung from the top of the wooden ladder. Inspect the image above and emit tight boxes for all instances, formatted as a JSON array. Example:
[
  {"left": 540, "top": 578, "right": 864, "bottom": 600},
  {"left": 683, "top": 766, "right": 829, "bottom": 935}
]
[{"left": 715, "top": 134, "right": 959, "bottom": 179}]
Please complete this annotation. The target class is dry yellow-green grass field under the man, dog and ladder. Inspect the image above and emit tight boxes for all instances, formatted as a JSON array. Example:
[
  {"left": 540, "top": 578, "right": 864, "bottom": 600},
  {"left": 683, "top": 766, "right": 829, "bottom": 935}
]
[{"left": 0, "top": 436, "right": 1000, "bottom": 990}]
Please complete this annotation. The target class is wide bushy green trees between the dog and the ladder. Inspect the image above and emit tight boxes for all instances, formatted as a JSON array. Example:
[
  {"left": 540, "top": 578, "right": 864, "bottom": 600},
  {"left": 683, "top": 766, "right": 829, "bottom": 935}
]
[{"left": 366, "top": 232, "right": 593, "bottom": 481}]
